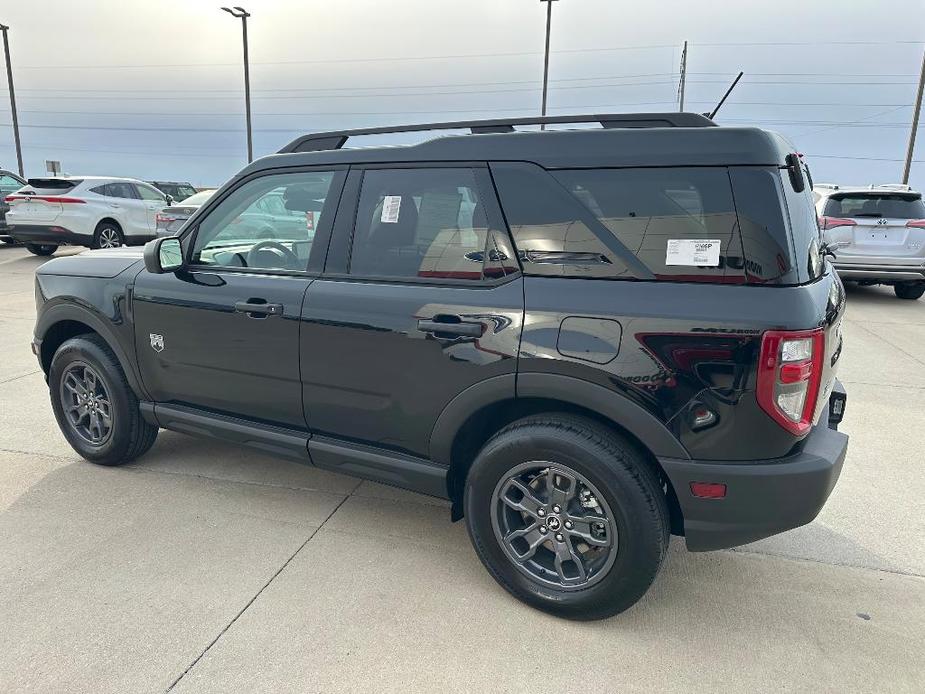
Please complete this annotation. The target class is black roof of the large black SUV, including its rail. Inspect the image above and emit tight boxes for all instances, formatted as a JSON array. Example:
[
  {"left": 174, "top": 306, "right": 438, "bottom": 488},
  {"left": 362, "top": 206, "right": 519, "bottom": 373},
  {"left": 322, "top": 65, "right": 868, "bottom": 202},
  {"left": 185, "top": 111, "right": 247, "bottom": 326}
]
[{"left": 241, "top": 113, "right": 793, "bottom": 174}]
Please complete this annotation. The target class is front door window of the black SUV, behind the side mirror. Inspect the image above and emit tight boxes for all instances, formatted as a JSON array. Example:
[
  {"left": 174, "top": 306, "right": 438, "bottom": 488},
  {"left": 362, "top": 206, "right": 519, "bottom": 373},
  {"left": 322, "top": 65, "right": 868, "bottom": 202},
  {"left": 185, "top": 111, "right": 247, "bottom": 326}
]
[{"left": 191, "top": 171, "right": 334, "bottom": 270}]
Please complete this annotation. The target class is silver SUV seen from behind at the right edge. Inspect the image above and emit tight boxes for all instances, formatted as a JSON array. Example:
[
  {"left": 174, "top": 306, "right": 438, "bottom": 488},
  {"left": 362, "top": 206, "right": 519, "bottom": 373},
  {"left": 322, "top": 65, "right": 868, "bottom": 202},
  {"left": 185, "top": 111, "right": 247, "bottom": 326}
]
[{"left": 813, "top": 183, "right": 925, "bottom": 299}]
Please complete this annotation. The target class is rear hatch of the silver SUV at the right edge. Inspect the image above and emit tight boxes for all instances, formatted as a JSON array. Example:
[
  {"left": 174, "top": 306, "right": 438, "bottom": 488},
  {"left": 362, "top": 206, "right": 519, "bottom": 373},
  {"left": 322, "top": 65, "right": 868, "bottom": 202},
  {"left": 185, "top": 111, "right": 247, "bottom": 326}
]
[{"left": 820, "top": 191, "right": 925, "bottom": 265}]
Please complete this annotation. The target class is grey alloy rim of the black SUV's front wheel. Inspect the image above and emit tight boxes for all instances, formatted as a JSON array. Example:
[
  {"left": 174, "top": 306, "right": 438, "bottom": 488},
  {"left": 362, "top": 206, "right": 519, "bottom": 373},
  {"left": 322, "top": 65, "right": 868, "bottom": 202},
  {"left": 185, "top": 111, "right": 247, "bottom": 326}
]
[{"left": 60, "top": 362, "right": 113, "bottom": 446}]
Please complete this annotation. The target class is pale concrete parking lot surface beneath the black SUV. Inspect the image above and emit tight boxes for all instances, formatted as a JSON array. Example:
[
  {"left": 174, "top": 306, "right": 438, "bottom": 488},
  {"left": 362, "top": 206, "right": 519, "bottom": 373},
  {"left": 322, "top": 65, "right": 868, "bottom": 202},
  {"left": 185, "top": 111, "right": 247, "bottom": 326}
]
[{"left": 0, "top": 245, "right": 925, "bottom": 693}]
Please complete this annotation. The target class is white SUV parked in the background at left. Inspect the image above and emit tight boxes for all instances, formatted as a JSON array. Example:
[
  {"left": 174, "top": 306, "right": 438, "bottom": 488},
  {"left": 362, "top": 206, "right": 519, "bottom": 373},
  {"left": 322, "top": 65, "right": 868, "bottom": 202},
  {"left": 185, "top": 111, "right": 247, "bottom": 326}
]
[{"left": 5, "top": 176, "right": 171, "bottom": 255}]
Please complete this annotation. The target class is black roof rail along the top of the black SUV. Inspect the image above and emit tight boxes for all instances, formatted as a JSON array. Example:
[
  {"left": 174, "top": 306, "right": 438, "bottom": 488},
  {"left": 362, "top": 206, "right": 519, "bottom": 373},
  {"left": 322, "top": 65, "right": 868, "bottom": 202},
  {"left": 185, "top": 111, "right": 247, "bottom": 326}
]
[{"left": 279, "top": 112, "right": 716, "bottom": 154}]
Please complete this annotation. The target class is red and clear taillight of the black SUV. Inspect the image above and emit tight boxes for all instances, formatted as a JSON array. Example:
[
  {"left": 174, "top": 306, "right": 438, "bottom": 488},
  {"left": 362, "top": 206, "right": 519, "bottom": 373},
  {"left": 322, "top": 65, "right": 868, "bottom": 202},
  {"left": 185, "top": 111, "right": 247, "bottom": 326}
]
[{"left": 757, "top": 328, "right": 825, "bottom": 436}]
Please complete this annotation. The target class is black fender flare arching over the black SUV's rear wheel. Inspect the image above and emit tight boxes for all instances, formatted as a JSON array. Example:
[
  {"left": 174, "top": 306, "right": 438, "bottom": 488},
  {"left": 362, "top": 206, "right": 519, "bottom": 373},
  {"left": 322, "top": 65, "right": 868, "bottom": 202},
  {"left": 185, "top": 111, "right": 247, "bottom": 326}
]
[{"left": 429, "top": 373, "right": 690, "bottom": 466}]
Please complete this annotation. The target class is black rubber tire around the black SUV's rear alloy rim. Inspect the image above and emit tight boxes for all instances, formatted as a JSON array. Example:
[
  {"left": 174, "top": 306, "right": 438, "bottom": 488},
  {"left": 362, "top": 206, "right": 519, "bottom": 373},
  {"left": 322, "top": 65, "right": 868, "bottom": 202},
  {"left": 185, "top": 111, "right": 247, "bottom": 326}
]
[{"left": 465, "top": 414, "right": 669, "bottom": 620}]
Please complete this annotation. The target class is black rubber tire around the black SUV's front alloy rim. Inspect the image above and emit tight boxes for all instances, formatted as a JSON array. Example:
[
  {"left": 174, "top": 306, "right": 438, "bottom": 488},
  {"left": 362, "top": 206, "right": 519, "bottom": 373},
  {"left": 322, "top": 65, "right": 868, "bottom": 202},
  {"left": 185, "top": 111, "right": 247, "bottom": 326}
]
[{"left": 48, "top": 333, "right": 158, "bottom": 465}]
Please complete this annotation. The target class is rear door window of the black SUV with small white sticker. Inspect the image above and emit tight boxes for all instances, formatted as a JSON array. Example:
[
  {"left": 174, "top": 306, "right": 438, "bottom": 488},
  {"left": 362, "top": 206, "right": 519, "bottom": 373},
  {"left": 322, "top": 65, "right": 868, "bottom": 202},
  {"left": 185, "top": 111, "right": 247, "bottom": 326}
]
[{"left": 350, "top": 168, "right": 490, "bottom": 280}]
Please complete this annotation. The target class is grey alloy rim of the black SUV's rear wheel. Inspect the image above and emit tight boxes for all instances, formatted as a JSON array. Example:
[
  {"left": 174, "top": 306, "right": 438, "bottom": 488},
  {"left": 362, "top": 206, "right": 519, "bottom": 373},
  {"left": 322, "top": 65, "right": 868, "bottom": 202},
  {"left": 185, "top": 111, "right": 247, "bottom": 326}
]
[{"left": 491, "top": 461, "right": 618, "bottom": 590}]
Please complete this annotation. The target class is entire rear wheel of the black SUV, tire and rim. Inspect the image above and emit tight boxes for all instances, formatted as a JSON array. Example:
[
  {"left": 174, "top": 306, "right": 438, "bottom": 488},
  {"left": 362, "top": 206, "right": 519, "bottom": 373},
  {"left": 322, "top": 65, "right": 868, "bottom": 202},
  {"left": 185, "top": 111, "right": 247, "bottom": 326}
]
[{"left": 465, "top": 414, "right": 669, "bottom": 620}]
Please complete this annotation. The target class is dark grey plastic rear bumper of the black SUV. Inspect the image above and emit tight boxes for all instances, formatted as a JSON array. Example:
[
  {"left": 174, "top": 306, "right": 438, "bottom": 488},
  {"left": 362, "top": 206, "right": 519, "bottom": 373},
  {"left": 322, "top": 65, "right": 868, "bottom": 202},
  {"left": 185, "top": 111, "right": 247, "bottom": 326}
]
[{"left": 659, "top": 385, "right": 848, "bottom": 552}]
